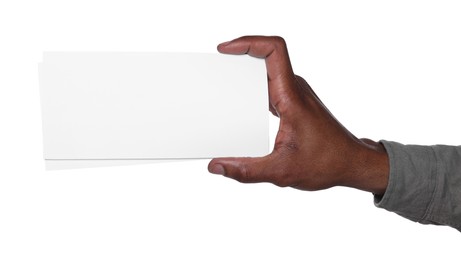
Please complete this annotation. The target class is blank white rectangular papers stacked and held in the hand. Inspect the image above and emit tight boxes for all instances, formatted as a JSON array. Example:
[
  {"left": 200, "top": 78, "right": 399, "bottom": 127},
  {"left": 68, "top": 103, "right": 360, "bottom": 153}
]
[{"left": 39, "top": 52, "right": 269, "bottom": 168}]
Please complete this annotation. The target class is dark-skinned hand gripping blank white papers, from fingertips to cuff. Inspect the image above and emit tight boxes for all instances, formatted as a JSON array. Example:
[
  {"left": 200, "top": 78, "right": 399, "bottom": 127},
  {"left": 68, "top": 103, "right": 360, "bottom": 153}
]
[{"left": 208, "top": 36, "right": 389, "bottom": 194}]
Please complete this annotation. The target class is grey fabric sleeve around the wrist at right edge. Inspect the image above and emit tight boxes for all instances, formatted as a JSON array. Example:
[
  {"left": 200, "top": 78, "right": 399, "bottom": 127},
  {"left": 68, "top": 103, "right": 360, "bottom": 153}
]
[{"left": 374, "top": 140, "right": 461, "bottom": 231}]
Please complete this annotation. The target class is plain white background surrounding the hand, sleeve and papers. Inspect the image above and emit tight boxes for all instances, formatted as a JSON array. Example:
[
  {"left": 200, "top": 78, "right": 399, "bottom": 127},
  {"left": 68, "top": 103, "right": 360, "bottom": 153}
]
[{"left": 0, "top": 0, "right": 461, "bottom": 259}]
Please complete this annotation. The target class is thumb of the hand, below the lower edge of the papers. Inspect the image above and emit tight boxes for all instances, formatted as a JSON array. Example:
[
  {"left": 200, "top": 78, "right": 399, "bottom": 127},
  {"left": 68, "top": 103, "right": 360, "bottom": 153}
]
[{"left": 208, "top": 155, "right": 271, "bottom": 183}]
